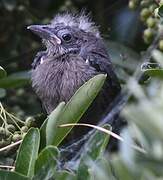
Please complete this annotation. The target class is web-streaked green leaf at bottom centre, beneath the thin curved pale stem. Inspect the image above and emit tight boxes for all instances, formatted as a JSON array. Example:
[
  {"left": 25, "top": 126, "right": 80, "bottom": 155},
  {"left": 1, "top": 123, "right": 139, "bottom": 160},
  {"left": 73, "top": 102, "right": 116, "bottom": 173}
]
[{"left": 78, "top": 125, "right": 111, "bottom": 180}]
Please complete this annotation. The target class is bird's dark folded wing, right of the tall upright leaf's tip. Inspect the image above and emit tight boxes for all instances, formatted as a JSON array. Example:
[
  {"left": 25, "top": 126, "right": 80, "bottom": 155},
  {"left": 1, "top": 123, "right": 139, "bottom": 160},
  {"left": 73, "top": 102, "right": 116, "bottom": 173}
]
[{"left": 79, "top": 53, "right": 121, "bottom": 126}]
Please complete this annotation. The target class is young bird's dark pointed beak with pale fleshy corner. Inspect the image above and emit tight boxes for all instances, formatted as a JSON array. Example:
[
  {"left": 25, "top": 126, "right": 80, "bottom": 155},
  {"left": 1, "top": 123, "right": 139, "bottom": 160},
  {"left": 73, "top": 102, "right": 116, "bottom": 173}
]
[{"left": 27, "top": 25, "right": 61, "bottom": 44}]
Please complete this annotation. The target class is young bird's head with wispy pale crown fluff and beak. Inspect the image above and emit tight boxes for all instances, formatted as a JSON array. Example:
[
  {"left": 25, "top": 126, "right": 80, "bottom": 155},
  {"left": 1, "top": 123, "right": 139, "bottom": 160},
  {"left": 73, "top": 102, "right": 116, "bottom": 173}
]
[{"left": 28, "top": 13, "right": 100, "bottom": 56}]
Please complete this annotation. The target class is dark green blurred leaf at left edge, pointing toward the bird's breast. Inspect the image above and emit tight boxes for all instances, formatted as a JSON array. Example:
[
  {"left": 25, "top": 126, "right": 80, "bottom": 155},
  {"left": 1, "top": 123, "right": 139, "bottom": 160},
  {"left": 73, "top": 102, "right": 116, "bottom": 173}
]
[{"left": 0, "top": 71, "right": 30, "bottom": 88}]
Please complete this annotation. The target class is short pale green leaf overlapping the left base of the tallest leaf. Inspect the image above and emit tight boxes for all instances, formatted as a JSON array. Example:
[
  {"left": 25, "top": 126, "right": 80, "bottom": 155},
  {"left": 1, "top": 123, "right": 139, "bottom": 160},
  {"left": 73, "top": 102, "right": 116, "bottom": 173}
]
[{"left": 46, "top": 102, "right": 65, "bottom": 145}]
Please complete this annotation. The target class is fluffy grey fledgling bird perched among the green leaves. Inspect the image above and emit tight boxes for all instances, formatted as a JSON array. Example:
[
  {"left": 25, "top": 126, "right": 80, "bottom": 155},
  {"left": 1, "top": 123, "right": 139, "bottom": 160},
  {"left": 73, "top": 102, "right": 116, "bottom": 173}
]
[{"left": 28, "top": 13, "right": 120, "bottom": 124}]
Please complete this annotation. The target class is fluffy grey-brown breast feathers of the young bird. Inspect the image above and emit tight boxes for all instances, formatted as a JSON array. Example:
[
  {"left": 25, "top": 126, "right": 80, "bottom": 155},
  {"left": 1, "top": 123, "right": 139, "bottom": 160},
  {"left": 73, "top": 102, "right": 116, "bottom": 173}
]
[{"left": 32, "top": 55, "right": 97, "bottom": 101}]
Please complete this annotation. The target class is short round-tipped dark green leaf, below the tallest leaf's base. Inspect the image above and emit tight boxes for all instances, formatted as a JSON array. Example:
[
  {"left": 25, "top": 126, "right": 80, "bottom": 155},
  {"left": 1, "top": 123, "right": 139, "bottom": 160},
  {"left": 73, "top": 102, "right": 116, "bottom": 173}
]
[{"left": 35, "top": 146, "right": 59, "bottom": 174}]
